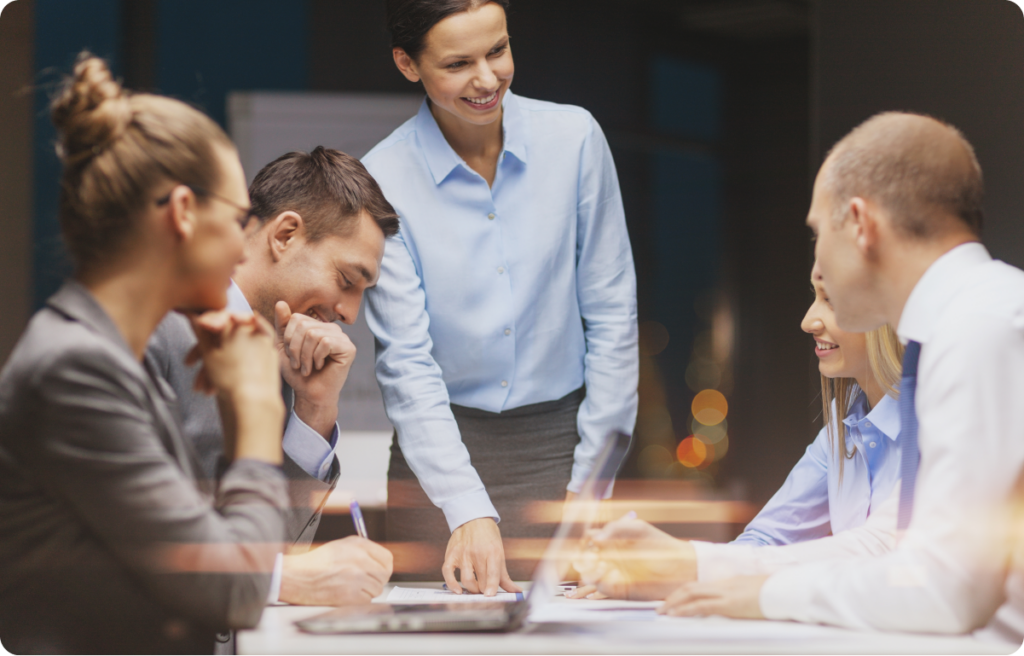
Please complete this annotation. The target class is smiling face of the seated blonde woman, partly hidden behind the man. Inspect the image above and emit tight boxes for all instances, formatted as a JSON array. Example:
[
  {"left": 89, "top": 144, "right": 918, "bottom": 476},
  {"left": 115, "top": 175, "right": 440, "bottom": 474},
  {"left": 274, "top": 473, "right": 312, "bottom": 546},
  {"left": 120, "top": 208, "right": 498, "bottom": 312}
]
[{"left": 800, "top": 264, "right": 869, "bottom": 379}]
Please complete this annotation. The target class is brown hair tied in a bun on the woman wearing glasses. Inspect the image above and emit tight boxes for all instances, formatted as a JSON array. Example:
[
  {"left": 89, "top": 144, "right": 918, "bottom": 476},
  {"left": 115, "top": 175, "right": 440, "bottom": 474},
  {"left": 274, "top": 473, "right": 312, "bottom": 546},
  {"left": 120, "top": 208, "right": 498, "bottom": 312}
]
[{"left": 50, "top": 52, "right": 234, "bottom": 274}]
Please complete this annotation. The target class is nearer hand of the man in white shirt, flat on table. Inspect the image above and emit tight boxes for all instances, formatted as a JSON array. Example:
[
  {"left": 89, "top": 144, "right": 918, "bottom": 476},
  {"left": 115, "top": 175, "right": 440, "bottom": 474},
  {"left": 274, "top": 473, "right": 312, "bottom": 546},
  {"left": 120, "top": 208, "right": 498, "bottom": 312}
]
[{"left": 657, "top": 576, "right": 768, "bottom": 619}]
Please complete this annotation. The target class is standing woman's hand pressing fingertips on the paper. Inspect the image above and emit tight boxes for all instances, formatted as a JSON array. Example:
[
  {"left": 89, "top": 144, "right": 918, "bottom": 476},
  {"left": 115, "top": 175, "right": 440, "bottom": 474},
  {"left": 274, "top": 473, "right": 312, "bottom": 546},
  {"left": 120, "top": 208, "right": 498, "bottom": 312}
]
[{"left": 441, "top": 517, "right": 522, "bottom": 597}]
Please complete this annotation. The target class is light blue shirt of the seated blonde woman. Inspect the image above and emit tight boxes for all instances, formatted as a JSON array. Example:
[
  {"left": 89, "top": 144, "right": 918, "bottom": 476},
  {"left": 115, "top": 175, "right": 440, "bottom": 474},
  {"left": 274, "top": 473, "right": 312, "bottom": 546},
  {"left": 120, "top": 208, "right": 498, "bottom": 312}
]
[{"left": 735, "top": 392, "right": 900, "bottom": 545}]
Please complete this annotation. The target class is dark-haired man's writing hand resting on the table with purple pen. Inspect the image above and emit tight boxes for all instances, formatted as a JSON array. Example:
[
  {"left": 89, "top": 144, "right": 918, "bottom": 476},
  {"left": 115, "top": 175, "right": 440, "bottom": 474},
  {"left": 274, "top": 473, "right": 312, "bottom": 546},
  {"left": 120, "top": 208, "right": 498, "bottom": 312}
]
[{"left": 279, "top": 536, "right": 393, "bottom": 606}]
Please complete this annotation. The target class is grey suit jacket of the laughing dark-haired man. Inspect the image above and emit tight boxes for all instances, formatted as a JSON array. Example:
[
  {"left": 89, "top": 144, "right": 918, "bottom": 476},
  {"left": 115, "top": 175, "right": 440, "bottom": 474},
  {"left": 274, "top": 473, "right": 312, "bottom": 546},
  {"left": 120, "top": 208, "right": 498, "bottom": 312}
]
[{"left": 145, "top": 312, "right": 341, "bottom": 546}]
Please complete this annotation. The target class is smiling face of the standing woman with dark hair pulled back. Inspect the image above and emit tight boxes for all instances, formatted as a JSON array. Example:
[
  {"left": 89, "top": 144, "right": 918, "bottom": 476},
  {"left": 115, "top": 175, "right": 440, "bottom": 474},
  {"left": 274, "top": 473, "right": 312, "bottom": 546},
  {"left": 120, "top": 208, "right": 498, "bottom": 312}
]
[{"left": 395, "top": 2, "right": 515, "bottom": 125}]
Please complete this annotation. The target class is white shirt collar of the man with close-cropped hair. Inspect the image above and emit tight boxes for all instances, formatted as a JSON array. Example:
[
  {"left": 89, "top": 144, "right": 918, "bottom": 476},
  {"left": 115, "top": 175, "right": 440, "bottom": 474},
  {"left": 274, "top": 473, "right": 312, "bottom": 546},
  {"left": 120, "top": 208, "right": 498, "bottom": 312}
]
[{"left": 896, "top": 242, "right": 992, "bottom": 344}]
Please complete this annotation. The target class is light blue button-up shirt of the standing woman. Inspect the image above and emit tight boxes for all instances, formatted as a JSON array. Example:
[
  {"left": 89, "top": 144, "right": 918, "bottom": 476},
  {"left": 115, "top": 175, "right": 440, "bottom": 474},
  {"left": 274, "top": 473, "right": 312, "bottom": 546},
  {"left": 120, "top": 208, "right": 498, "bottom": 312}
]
[{"left": 364, "top": 92, "right": 638, "bottom": 530}]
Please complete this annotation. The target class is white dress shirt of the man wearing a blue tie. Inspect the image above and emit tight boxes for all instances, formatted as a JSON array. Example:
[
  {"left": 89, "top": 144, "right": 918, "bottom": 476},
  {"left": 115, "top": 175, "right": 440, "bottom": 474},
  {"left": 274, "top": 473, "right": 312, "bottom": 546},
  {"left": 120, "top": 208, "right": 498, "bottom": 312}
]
[{"left": 761, "top": 244, "right": 1024, "bottom": 633}]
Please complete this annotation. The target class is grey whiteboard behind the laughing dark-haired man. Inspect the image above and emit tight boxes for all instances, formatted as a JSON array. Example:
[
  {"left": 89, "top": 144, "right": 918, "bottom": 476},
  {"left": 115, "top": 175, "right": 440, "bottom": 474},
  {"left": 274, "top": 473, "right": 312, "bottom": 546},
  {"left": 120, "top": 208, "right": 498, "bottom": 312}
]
[{"left": 227, "top": 91, "right": 423, "bottom": 431}]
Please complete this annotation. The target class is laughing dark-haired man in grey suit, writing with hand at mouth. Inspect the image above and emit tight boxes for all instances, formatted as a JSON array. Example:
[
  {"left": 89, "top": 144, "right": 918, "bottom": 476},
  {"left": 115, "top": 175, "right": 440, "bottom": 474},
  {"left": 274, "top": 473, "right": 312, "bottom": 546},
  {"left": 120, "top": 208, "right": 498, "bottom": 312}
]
[{"left": 146, "top": 147, "right": 398, "bottom": 609}]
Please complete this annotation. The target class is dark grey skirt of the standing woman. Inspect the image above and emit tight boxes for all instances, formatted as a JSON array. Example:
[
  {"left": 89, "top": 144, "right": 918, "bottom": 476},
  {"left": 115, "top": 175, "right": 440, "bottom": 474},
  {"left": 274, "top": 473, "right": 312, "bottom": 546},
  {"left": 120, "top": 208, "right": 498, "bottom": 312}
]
[{"left": 387, "top": 388, "right": 586, "bottom": 580}]
